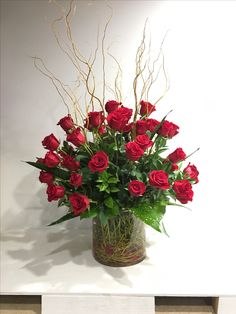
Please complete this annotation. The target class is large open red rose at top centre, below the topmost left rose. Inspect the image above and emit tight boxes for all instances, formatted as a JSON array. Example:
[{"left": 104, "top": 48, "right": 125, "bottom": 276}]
[{"left": 107, "top": 107, "right": 133, "bottom": 132}]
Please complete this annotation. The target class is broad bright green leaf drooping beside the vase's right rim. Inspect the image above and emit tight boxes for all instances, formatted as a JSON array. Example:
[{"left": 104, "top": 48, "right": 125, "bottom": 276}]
[{"left": 130, "top": 202, "right": 166, "bottom": 232}]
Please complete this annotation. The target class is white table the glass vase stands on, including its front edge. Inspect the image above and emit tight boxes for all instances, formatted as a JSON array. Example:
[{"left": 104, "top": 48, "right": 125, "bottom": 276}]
[{"left": 0, "top": 227, "right": 236, "bottom": 314}]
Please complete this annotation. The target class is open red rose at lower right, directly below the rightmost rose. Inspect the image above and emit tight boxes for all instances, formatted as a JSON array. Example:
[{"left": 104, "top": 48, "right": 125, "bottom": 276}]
[{"left": 173, "top": 180, "right": 193, "bottom": 204}]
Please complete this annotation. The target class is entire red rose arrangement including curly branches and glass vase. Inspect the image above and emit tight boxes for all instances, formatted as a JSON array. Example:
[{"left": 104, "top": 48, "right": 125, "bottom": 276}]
[{"left": 25, "top": 0, "right": 199, "bottom": 266}]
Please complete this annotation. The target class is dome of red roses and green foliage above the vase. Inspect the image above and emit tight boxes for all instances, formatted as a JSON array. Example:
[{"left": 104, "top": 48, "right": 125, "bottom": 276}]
[{"left": 29, "top": 100, "right": 199, "bottom": 229}]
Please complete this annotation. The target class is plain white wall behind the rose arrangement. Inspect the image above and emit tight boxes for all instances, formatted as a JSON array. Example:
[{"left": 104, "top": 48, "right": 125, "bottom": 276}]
[{"left": 1, "top": 0, "right": 236, "bottom": 254}]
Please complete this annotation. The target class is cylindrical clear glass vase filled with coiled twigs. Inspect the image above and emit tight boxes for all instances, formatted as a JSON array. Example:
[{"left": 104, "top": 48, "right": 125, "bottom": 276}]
[{"left": 93, "top": 211, "right": 146, "bottom": 267}]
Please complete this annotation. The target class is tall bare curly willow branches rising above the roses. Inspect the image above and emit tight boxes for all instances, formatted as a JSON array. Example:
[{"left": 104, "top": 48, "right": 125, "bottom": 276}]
[{"left": 32, "top": 0, "right": 169, "bottom": 122}]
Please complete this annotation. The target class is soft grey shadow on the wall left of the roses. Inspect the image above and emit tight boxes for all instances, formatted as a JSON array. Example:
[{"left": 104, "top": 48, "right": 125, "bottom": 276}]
[{"left": 2, "top": 171, "right": 91, "bottom": 230}]
